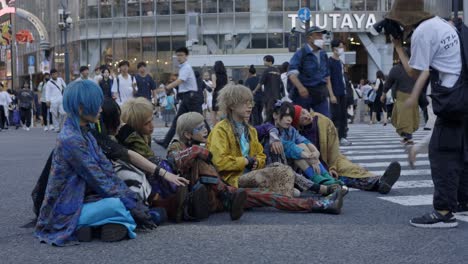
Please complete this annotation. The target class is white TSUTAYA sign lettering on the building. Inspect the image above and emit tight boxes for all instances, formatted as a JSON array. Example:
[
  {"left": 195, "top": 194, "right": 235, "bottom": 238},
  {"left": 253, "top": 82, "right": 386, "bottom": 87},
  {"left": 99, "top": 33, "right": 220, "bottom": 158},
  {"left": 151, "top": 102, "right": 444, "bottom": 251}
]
[{"left": 288, "top": 12, "right": 385, "bottom": 32}]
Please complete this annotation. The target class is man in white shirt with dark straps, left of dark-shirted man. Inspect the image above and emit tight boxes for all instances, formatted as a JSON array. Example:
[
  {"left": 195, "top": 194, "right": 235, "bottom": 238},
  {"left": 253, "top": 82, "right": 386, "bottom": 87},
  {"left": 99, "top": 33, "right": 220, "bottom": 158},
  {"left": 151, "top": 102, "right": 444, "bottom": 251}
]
[{"left": 111, "top": 61, "right": 138, "bottom": 106}]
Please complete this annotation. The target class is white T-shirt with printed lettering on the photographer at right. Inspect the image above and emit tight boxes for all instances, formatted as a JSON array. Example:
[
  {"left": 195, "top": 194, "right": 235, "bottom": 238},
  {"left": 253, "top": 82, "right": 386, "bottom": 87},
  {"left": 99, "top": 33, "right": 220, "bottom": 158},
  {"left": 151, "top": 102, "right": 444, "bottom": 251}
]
[{"left": 409, "top": 17, "right": 462, "bottom": 88}]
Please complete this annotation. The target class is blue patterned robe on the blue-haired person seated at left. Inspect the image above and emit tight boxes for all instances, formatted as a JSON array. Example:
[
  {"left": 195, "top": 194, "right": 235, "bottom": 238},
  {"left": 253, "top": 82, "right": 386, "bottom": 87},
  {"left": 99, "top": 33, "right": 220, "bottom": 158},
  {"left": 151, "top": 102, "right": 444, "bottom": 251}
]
[{"left": 35, "top": 119, "right": 137, "bottom": 246}]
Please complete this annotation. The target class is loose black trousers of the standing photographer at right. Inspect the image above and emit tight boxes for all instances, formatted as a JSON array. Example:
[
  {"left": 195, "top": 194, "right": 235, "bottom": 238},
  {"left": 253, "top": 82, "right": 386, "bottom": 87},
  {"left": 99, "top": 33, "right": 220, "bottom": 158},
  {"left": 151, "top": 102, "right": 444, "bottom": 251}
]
[{"left": 429, "top": 118, "right": 468, "bottom": 212}]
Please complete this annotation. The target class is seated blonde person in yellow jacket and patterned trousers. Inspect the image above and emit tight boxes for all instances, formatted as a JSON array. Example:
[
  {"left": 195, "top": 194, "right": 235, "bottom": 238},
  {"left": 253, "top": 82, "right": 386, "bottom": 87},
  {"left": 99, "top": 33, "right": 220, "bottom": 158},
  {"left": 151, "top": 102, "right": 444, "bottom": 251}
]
[{"left": 207, "top": 84, "right": 343, "bottom": 214}]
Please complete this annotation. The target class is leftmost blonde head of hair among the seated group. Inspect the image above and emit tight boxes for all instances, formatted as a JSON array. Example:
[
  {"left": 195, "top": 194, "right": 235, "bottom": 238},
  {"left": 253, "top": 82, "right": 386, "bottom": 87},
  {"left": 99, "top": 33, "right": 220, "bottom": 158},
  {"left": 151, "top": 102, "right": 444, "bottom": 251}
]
[{"left": 120, "top": 97, "right": 153, "bottom": 132}]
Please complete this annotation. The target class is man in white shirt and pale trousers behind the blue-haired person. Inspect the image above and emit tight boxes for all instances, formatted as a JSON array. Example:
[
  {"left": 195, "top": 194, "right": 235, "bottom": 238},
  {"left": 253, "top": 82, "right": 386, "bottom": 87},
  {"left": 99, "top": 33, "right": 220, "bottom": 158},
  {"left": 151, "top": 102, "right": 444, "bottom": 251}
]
[{"left": 45, "top": 69, "right": 67, "bottom": 132}]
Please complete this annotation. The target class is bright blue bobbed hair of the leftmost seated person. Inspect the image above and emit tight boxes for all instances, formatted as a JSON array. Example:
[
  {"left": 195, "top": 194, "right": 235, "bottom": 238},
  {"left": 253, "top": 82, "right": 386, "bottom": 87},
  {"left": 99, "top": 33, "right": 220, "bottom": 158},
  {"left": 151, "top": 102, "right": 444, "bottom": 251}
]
[{"left": 63, "top": 80, "right": 104, "bottom": 128}]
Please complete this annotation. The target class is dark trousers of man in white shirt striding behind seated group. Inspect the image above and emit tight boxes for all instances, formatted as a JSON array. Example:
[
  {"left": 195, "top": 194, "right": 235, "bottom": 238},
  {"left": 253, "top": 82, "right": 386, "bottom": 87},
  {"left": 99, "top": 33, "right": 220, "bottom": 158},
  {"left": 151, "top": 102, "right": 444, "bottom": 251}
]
[{"left": 163, "top": 92, "right": 204, "bottom": 148}]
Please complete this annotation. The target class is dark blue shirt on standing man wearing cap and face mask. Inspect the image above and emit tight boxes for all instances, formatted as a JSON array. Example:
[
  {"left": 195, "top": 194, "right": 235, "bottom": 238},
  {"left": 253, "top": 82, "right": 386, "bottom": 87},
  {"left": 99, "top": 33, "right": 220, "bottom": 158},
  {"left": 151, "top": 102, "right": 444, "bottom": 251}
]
[{"left": 288, "top": 44, "right": 330, "bottom": 88}]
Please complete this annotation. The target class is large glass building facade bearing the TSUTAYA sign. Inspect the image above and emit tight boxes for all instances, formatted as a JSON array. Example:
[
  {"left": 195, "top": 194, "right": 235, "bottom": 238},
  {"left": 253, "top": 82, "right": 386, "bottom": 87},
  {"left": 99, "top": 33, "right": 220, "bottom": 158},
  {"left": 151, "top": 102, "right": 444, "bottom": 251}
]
[{"left": 14, "top": 0, "right": 451, "bottom": 85}]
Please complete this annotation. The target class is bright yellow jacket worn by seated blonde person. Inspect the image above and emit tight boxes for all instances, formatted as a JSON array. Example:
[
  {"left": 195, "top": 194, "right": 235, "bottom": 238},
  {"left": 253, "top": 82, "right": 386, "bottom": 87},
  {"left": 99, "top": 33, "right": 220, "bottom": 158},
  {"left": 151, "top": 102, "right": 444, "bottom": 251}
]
[{"left": 207, "top": 119, "right": 266, "bottom": 187}]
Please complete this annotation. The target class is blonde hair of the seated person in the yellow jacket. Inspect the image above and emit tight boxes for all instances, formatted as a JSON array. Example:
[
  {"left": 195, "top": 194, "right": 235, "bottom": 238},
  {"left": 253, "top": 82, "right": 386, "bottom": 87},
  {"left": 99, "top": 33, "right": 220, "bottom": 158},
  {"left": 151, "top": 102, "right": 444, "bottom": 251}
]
[{"left": 218, "top": 84, "right": 253, "bottom": 117}]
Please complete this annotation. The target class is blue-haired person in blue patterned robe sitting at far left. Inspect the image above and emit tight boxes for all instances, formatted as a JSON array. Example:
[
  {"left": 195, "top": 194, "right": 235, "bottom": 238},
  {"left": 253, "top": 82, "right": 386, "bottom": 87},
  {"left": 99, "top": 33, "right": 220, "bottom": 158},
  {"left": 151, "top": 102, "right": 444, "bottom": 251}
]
[{"left": 35, "top": 80, "right": 156, "bottom": 246}]
